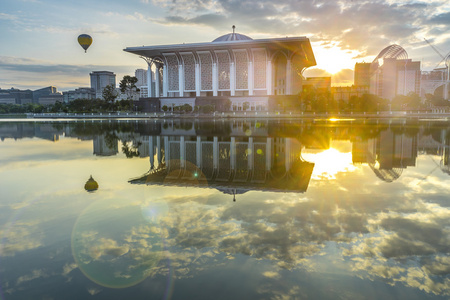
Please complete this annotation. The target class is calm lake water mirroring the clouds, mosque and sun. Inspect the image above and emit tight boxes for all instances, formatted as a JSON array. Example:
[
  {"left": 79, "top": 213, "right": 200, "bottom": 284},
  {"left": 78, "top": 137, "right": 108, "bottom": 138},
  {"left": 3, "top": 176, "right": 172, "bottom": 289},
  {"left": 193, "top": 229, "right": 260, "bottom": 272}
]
[{"left": 0, "top": 120, "right": 450, "bottom": 299}]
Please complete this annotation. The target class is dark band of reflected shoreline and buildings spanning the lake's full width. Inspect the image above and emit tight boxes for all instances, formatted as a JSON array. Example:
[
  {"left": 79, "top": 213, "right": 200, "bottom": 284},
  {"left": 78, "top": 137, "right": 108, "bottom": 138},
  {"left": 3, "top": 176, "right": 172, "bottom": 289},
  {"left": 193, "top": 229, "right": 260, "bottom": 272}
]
[{"left": 0, "top": 119, "right": 450, "bottom": 183}]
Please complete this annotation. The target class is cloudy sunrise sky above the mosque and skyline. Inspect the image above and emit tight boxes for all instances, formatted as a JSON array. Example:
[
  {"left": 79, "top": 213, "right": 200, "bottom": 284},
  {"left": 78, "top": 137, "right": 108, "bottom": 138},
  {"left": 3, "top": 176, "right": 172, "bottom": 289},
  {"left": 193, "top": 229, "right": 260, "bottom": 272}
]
[{"left": 0, "top": 0, "right": 450, "bottom": 91}]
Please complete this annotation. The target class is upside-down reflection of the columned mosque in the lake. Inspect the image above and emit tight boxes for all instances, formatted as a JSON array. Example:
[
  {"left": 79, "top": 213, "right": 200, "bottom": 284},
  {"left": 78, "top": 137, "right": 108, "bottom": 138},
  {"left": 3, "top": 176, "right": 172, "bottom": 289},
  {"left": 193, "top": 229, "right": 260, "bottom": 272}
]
[{"left": 130, "top": 136, "right": 314, "bottom": 195}]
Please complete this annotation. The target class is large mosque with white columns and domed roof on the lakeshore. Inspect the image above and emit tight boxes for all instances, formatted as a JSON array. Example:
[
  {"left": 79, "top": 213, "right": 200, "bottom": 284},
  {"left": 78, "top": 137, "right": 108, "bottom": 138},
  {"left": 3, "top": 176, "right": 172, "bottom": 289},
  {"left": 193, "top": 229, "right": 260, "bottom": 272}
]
[{"left": 124, "top": 26, "right": 316, "bottom": 111}]
